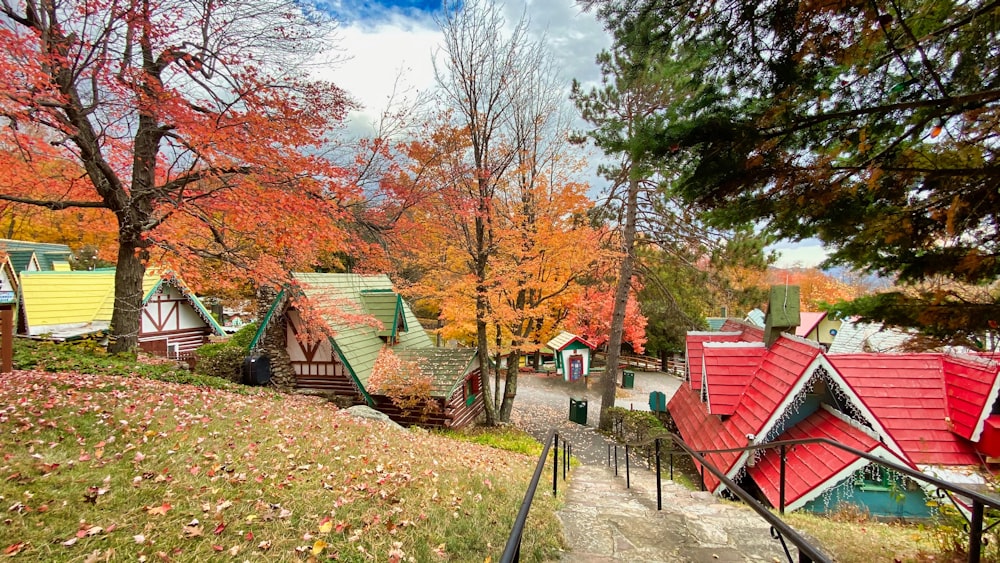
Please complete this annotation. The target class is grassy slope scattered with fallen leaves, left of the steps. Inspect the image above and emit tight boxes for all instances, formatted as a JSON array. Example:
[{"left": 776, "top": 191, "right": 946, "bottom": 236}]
[{"left": 0, "top": 371, "right": 559, "bottom": 562}]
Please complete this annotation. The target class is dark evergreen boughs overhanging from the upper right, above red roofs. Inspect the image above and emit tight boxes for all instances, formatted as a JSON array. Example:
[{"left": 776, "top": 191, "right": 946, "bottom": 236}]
[{"left": 593, "top": 0, "right": 1000, "bottom": 340}]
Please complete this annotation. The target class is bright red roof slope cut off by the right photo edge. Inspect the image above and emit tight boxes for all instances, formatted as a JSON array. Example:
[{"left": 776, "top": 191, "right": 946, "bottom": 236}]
[{"left": 941, "top": 356, "right": 998, "bottom": 442}]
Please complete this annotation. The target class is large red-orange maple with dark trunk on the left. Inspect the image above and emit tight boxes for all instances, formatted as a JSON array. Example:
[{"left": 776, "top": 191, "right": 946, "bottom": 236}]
[{"left": 0, "top": 0, "right": 359, "bottom": 350}]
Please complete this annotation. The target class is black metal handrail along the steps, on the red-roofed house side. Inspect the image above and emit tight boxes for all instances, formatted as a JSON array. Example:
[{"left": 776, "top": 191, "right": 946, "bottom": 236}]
[{"left": 609, "top": 432, "right": 1000, "bottom": 563}]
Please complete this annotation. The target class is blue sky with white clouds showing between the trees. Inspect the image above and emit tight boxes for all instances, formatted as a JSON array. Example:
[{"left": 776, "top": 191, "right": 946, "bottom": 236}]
[{"left": 318, "top": 0, "right": 826, "bottom": 268}]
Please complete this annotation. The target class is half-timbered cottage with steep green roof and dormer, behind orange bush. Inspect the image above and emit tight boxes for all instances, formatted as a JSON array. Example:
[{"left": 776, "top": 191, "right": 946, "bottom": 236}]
[{"left": 251, "top": 273, "right": 485, "bottom": 427}]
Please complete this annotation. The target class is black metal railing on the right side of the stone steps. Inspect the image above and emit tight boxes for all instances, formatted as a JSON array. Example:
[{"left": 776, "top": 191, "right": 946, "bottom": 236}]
[{"left": 608, "top": 433, "right": 1000, "bottom": 563}]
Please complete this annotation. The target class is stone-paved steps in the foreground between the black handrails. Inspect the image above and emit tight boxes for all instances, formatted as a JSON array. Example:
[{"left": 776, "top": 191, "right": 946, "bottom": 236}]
[{"left": 558, "top": 459, "right": 797, "bottom": 563}]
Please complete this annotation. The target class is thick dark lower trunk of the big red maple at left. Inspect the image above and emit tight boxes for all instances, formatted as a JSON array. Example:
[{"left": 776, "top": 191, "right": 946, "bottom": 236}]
[{"left": 108, "top": 232, "right": 148, "bottom": 353}]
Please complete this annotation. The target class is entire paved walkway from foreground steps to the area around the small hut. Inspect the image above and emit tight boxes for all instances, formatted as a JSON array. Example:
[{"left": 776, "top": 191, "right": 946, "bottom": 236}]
[{"left": 511, "top": 372, "right": 812, "bottom": 563}]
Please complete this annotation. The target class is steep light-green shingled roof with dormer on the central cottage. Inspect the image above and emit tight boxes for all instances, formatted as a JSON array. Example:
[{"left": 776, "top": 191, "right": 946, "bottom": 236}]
[{"left": 280, "top": 273, "right": 432, "bottom": 388}]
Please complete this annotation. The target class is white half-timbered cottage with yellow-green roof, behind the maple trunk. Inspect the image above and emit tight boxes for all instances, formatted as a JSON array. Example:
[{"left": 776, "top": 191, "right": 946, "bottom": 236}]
[{"left": 18, "top": 268, "right": 224, "bottom": 359}]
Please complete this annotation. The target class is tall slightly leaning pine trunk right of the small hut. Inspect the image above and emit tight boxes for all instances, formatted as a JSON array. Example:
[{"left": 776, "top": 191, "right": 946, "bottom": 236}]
[{"left": 600, "top": 177, "right": 639, "bottom": 431}]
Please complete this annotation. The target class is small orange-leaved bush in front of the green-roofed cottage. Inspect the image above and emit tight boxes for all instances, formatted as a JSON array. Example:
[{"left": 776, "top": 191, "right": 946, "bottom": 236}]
[{"left": 368, "top": 346, "right": 440, "bottom": 424}]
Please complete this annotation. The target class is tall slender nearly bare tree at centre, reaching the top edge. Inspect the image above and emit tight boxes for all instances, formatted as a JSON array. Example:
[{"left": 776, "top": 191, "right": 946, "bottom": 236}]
[{"left": 435, "top": 0, "right": 564, "bottom": 424}]
